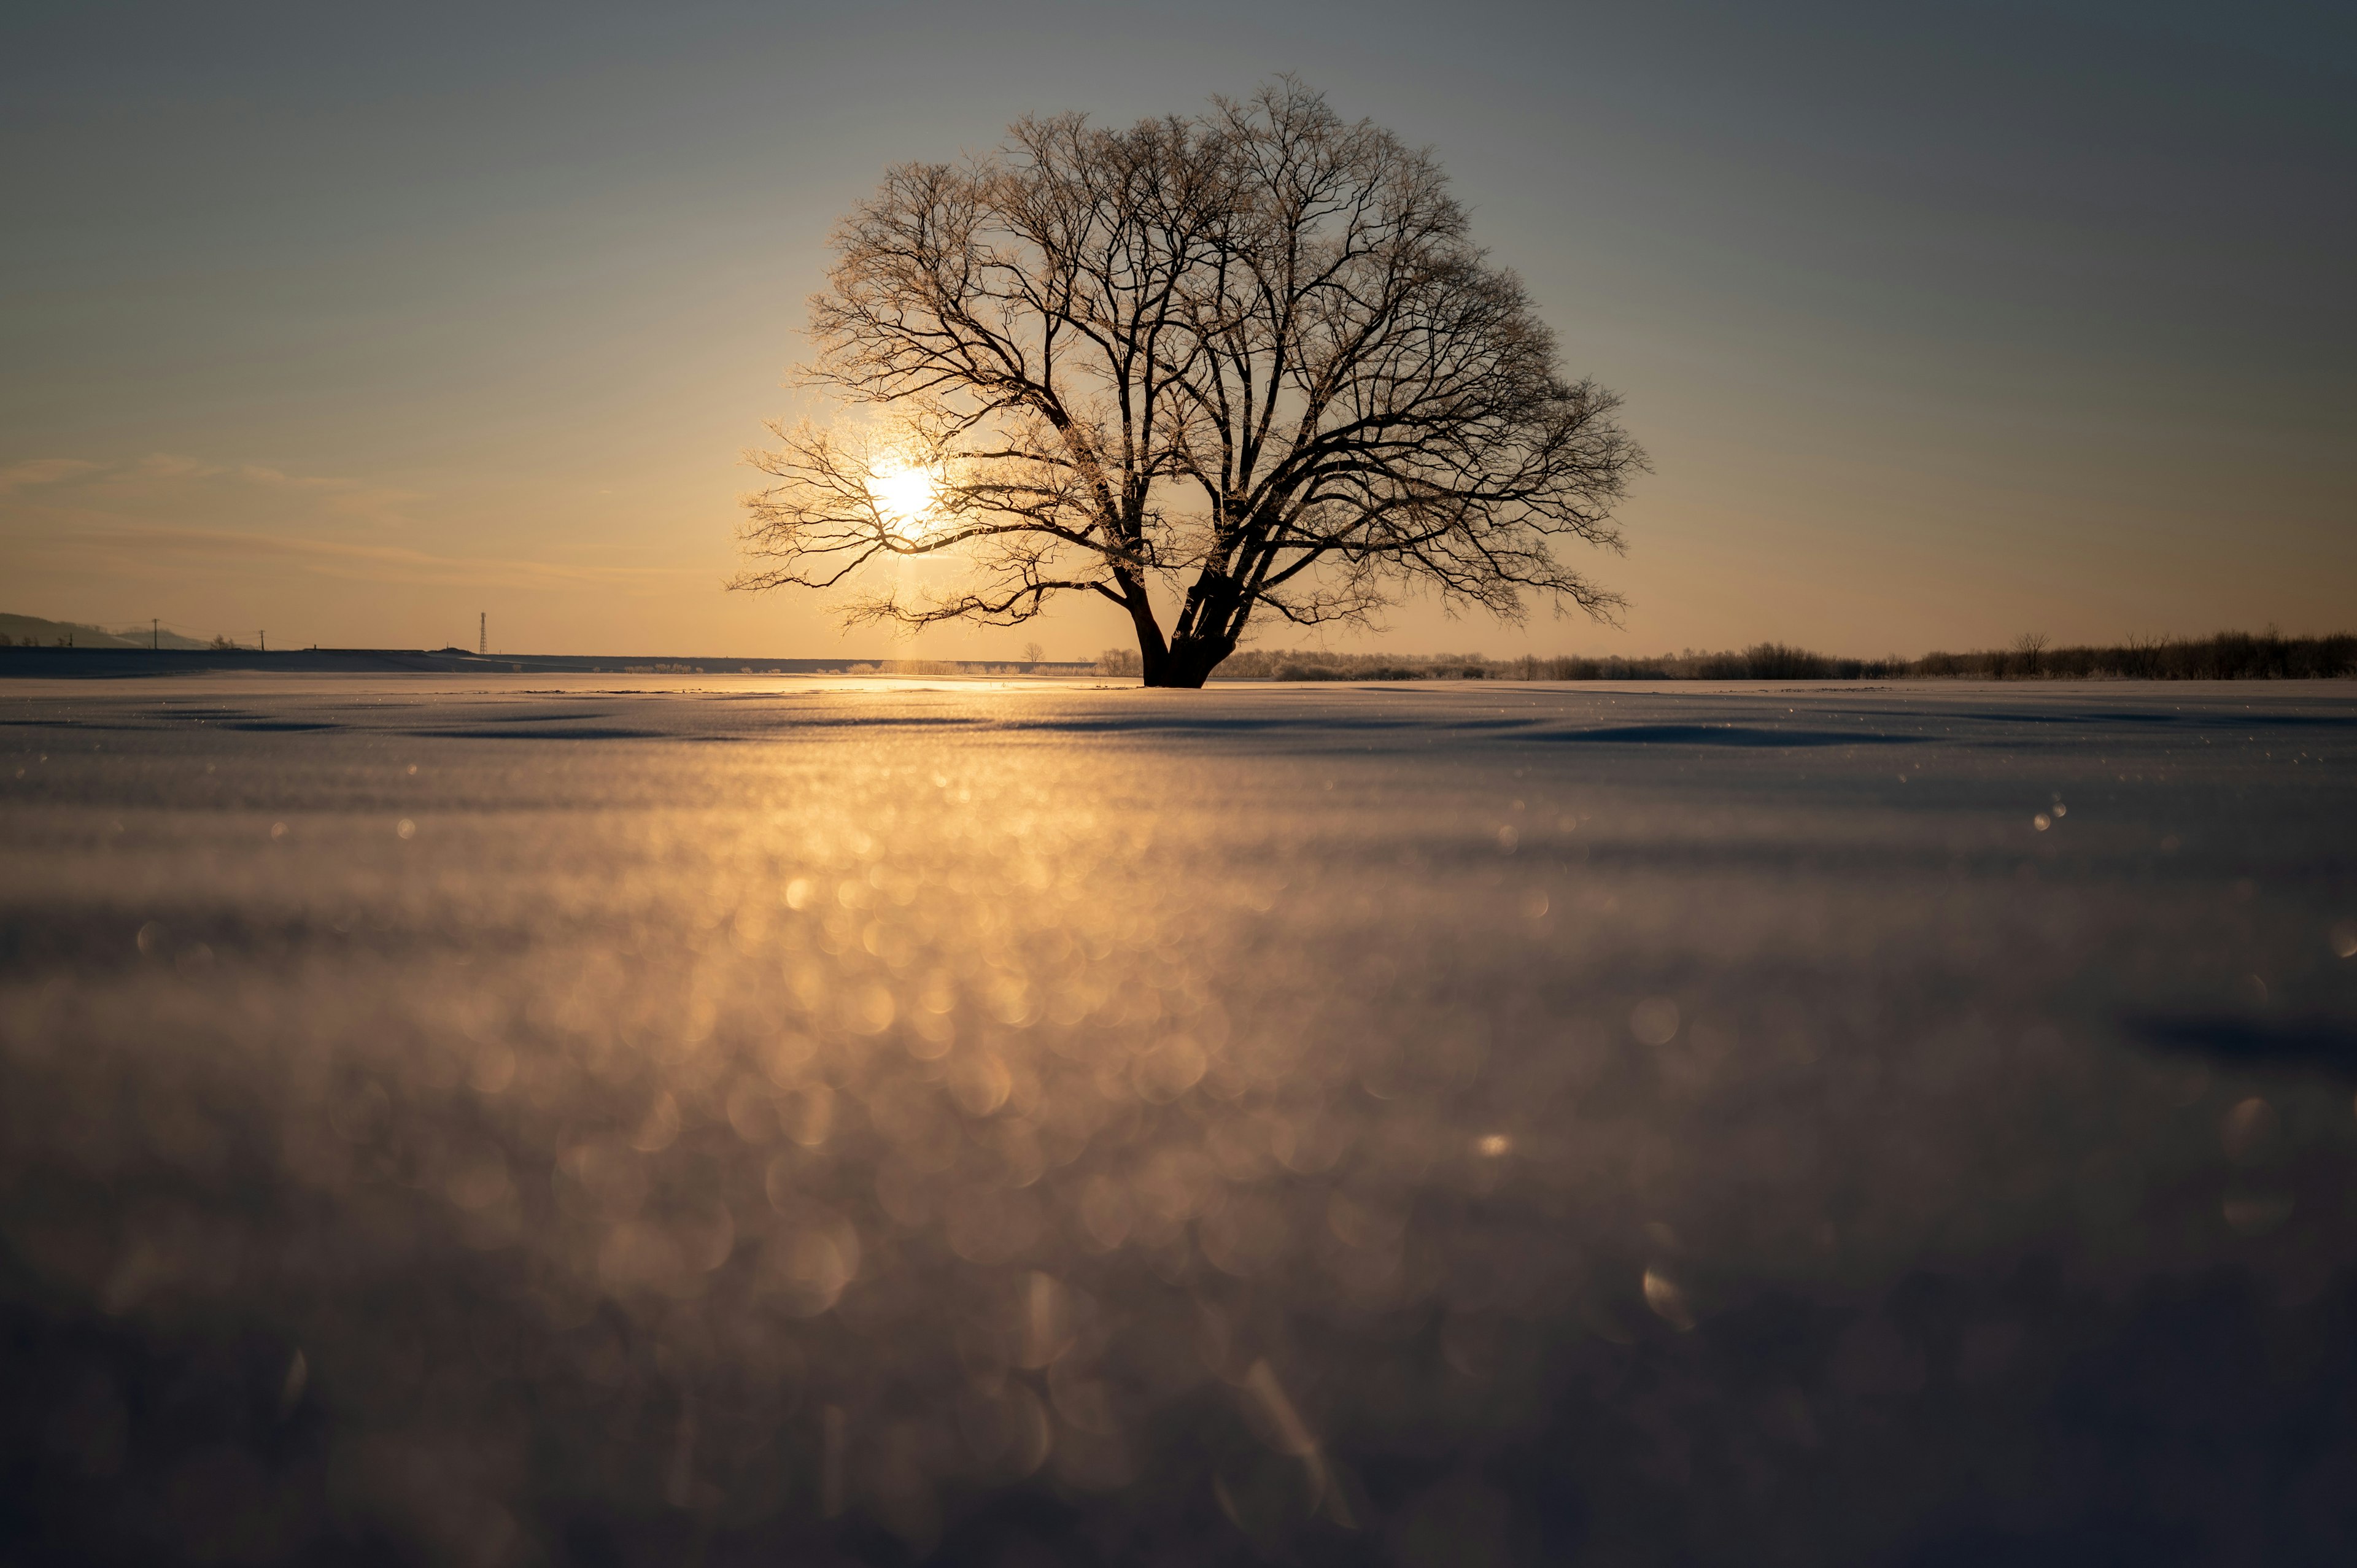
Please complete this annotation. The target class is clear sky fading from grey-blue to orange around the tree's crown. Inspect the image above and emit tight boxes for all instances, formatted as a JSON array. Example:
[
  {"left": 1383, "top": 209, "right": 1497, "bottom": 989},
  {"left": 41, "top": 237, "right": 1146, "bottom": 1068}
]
[{"left": 0, "top": 0, "right": 2357, "bottom": 658}]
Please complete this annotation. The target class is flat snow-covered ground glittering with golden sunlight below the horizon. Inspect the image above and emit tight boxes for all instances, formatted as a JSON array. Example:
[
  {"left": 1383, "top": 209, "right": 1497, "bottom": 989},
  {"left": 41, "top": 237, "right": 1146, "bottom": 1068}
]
[{"left": 0, "top": 677, "right": 2357, "bottom": 1568}]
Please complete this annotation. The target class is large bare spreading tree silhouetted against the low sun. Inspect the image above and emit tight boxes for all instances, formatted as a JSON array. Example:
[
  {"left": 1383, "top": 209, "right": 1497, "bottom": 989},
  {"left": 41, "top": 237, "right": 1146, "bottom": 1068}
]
[{"left": 730, "top": 78, "right": 1645, "bottom": 686}]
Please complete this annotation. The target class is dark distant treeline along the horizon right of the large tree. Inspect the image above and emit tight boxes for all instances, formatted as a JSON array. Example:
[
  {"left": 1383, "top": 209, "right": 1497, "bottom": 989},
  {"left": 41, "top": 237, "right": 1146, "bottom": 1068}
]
[{"left": 1207, "top": 632, "right": 2357, "bottom": 681}]
